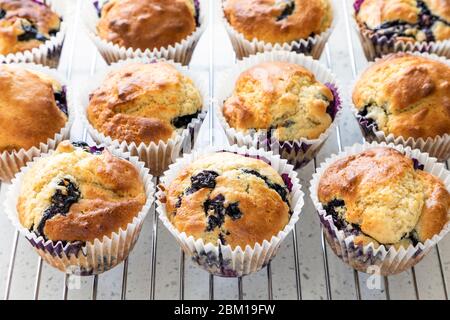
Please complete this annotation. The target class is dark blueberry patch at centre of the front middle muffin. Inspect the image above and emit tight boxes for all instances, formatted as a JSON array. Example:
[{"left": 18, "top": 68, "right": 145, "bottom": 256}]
[{"left": 203, "top": 194, "right": 242, "bottom": 232}]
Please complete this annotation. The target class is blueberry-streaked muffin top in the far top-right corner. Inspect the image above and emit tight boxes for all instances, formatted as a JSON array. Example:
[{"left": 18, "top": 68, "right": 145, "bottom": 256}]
[{"left": 356, "top": 0, "right": 450, "bottom": 42}]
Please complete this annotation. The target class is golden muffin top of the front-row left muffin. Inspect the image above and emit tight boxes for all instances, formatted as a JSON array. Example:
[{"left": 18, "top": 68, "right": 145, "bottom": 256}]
[{"left": 17, "top": 141, "right": 146, "bottom": 242}]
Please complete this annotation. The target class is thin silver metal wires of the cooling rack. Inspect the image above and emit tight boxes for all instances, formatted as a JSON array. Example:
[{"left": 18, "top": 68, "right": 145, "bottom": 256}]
[{"left": 0, "top": 0, "right": 449, "bottom": 300}]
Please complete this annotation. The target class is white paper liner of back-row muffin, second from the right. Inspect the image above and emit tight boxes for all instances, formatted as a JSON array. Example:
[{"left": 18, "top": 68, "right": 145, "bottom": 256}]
[{"left": 220, "top": 0, "right": 337, "bottom": 60}]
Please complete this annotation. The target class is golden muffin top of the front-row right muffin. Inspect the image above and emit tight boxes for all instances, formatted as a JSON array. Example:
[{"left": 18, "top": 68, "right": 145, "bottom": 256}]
[{"left": 318, "top": 147, "right": 450, "bottom": 247}]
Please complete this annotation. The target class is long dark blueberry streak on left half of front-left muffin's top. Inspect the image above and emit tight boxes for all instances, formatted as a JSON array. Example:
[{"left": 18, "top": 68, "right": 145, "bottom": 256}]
[{"left": 35, "top": 179, "right": 81, "bottom": 237}]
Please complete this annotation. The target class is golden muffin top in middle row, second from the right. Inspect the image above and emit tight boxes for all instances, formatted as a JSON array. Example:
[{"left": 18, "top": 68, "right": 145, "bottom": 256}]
[{"left": 223, "top": 62, "right": 334, "bottom": 141}]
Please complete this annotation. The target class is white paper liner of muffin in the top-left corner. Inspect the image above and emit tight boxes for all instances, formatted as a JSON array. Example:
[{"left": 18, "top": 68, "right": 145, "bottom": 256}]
[{"left": 0, "top": 0, "right": 71, "bottom": 68}]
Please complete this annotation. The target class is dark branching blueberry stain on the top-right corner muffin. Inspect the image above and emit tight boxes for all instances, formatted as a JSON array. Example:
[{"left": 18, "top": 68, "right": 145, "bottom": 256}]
[{"left": 374, "top": 1, "right": 450, "bottom": 41}]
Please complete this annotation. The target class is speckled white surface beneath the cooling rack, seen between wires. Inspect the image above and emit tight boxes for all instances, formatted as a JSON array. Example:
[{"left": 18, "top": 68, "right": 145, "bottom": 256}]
[{"left": 0, "top": 0, "right": 450, "bottom": 299}]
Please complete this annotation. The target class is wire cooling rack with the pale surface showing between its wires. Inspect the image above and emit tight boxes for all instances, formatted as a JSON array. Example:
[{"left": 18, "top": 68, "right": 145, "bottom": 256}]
[{"left": 0, "top": 0, "right": 450, "bottom": 300}]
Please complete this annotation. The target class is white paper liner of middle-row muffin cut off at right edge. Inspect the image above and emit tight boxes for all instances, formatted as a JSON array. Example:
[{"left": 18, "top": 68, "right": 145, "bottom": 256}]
[{"left": 350, "top": 52, "right": 450, "bottom": 161}]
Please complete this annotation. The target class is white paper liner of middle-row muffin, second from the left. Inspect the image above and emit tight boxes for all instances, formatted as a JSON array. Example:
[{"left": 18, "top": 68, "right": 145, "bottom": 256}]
[{"left": 78, "top": 57, "right": 208, "bottom": 176}]
